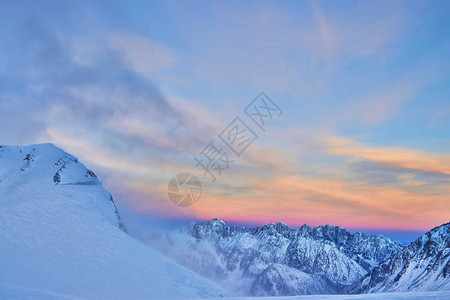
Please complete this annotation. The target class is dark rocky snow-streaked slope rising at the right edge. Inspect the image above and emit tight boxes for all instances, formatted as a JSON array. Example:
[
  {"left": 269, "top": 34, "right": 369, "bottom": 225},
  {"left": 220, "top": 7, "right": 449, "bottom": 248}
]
[{"left": 351, "top": 223, "right": 450, "bottom": 293}]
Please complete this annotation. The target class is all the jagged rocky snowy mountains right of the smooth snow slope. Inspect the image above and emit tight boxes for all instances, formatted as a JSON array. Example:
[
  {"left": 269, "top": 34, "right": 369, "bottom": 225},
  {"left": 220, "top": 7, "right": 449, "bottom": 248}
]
[{"left": 149, "top": 219, "right": 450, "bottom": 296}]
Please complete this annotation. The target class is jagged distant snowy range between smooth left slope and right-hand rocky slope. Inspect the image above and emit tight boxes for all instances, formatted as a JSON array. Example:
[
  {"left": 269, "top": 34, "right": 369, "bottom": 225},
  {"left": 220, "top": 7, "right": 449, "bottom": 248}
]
[{"left": 149, "top": 219, "right": 402, "bottom": 296}]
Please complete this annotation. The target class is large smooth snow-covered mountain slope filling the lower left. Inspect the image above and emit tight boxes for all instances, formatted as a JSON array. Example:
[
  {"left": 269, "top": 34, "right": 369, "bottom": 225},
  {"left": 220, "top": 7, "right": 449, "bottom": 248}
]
[{"left": 0, "top": 144, "right": 224, "bottom": 299}]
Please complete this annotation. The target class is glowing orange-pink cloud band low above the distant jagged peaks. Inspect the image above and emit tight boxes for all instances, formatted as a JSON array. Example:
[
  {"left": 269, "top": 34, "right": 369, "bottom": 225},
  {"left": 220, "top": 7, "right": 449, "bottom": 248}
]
[{"left": 190, "top": 172, "right": 448, "bottom": 229}]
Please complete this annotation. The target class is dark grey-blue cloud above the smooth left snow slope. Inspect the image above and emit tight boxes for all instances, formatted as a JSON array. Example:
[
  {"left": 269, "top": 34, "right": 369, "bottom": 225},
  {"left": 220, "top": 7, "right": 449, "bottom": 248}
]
[{"left": 1, "top": 18, "right": 179, "bottom": 136}]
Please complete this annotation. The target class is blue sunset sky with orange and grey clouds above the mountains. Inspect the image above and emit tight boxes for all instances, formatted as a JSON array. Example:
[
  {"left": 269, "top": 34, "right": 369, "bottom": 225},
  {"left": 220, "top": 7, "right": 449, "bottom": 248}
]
[{"left": 0, "top": 1, "right": 450, "bottom": 239}]
